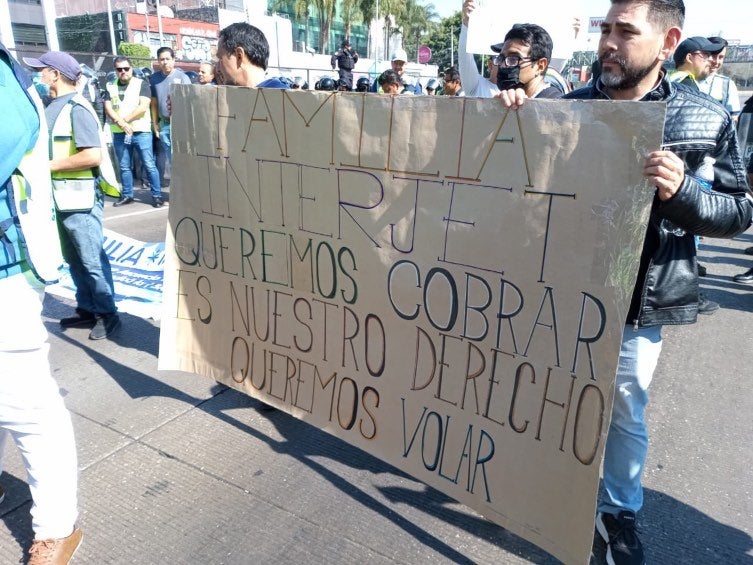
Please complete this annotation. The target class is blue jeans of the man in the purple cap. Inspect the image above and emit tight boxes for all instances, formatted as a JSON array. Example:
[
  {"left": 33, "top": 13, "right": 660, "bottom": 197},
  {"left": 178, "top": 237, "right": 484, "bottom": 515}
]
[{"left": 57, "top": 188, "right": 117, "bottom": 314}]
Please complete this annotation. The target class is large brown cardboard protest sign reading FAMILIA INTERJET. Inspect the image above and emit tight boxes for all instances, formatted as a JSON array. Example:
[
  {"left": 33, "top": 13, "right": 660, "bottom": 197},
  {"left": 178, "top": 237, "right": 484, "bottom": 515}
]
[{"left": 160, "top": 86, "right": 664, "bottom": 562}]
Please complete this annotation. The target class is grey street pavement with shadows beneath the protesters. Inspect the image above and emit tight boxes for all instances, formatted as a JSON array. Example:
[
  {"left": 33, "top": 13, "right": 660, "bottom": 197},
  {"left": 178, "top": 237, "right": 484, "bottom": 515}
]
[{"left": 0, "top": 200, "right": 753, "bottom": 565}]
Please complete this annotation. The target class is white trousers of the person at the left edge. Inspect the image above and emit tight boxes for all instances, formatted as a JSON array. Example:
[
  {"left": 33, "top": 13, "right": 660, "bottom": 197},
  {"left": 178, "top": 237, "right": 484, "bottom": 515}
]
[{"left": 0, "top": 275, "right": 78, "bottom": 539}]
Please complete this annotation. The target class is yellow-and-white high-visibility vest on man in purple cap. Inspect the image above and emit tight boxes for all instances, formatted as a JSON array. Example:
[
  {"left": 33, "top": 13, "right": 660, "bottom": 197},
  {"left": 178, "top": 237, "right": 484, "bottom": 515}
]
[{"left": 50, "top": 93, "right": 120, "bottom": 198}]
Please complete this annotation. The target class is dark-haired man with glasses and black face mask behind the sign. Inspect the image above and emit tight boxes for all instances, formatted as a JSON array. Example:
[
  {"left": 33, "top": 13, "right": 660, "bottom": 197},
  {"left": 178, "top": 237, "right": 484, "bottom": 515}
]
[{"left": 492, "top": 24, "right": 562, "bottom": 98}]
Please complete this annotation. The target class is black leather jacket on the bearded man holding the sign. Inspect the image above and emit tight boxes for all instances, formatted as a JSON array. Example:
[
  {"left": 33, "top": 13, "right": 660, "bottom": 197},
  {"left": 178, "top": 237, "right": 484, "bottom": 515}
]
[{"left": 565, "top": 77, "right": 753, "bottom": 327}]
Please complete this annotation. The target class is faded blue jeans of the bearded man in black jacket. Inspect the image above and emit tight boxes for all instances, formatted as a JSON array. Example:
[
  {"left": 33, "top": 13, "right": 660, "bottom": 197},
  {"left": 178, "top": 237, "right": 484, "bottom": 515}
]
[{"left": 599, "top": 326, "right": 662, "bottom": 514}]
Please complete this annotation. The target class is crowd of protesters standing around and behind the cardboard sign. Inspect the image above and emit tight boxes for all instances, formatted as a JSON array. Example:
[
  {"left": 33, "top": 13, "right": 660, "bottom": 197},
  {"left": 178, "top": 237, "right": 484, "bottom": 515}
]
[{"left": 0, "top": 0, "right": 753, "bottom": 565}]
